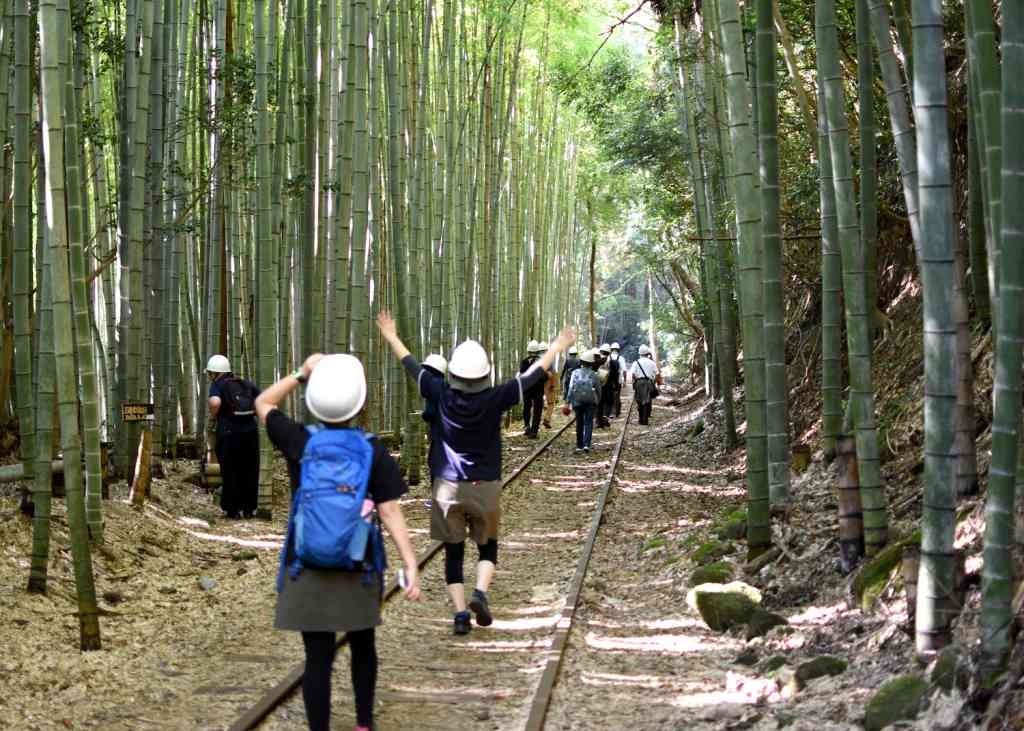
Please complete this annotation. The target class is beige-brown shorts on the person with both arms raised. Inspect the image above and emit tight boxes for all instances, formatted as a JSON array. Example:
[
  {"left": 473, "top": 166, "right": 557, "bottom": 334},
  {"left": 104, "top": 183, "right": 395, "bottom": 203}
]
[{"left": 430, "top": 477, "right": 502, "bottom": 544}]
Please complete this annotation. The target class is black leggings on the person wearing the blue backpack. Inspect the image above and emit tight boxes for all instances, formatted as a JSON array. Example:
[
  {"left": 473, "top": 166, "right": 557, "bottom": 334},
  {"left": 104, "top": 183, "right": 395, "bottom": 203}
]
[{"left": 302, "top": 628, "right": 377, "bottom": 731}]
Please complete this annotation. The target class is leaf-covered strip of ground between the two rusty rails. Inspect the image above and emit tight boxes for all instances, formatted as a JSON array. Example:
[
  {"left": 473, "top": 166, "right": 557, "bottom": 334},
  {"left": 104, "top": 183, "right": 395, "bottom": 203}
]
[{"left": 265, "top": 407, "right": 623, "bottom": 731}]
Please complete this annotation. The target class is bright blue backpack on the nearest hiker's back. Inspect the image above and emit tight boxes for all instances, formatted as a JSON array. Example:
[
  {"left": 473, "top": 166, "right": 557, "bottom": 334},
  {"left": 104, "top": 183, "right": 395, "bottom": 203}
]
[{"left": 278, "top": 426, "right": 385, "bottom": 591}]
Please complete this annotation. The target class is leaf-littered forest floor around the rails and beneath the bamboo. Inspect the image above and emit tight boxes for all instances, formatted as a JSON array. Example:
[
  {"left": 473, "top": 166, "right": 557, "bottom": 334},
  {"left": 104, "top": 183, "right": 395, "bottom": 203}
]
[{"left": 0, "top": 290, "right": 1024, "bottom": 731}]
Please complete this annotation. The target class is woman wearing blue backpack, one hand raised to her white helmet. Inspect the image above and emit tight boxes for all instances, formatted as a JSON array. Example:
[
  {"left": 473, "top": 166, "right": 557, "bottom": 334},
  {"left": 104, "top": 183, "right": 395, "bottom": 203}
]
[{"left": 256, "top": 353, "right": 420, "bottom": 731}]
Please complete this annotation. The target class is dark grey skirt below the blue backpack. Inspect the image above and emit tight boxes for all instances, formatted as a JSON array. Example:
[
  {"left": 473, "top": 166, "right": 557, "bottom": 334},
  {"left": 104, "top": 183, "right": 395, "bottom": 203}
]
[{"left": 273, "top": 568, "right": 381, "bottom": 632}]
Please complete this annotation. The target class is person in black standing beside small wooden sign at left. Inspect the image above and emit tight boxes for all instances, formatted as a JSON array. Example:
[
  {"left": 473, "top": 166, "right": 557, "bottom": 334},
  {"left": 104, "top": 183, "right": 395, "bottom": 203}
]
[{"left": 206, "top": 354, "right": 259, "bottom": 520}]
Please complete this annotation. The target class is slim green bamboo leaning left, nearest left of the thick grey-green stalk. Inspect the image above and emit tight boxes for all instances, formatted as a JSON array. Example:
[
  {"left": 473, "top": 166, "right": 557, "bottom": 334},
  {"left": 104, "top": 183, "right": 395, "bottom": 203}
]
[{"left": 815, "top": 0, "right": 889, "bottom": 556}]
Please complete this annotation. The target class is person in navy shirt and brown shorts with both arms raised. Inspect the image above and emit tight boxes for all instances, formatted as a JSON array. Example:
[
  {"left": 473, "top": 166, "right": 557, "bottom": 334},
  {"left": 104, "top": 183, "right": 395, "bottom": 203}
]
[{"left": 377, "top": 312, "right": 575, "bottom": 635}]
